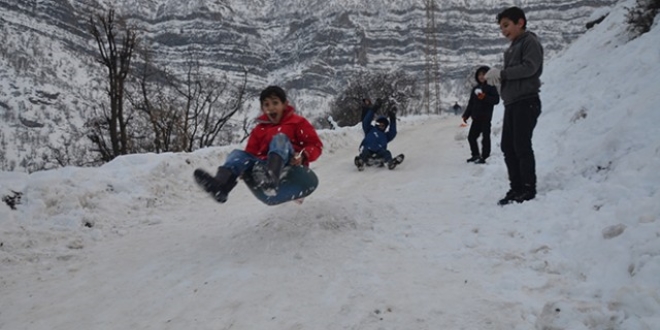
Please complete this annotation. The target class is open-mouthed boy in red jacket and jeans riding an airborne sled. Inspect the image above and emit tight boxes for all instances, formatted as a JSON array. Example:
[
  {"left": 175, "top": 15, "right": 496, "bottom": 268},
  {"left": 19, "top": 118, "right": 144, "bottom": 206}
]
[{"left": 194, "top": 86, "right": 323, "bottom": 203}]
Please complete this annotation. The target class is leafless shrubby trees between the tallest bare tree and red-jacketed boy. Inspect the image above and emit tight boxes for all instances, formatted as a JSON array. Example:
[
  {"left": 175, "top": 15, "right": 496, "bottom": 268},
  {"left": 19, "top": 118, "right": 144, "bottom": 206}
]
[{"left": 127, "top": 48, "right": 247, "bottom": 152}]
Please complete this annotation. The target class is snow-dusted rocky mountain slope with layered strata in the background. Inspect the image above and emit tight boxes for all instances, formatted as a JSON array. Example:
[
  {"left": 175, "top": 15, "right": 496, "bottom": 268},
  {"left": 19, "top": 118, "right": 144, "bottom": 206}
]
[{"left": 0, "top": 0, "right": 615, "bottom": 170}]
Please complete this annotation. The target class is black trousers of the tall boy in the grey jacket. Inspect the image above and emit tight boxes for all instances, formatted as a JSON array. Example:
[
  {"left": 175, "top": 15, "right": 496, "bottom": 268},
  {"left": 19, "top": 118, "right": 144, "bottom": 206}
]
[{"left": 502, "top": 96, "right": 541, "bottom": 192}]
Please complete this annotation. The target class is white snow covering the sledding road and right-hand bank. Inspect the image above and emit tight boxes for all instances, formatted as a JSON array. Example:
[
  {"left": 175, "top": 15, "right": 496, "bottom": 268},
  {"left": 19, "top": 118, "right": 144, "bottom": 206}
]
[{"left": 0, "top": 1, "right": 660, "bottom": 330}]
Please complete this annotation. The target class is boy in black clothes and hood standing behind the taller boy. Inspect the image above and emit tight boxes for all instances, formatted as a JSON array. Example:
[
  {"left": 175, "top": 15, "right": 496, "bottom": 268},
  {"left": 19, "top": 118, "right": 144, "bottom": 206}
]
[{"left": 463, "top": 66, "right": 500, "bottom": 164}]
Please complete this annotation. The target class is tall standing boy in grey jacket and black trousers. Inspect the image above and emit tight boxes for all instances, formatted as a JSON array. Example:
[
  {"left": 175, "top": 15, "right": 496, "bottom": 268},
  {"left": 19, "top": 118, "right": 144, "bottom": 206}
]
[{"left": 486, "top": 7, "right": 543, "bottom": 205}]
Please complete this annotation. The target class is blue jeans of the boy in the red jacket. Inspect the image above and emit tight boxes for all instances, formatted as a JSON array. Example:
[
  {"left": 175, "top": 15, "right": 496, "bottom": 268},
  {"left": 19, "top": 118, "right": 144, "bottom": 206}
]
[{"left": 222, "top": 133, "right": 294, "bottom": 177}]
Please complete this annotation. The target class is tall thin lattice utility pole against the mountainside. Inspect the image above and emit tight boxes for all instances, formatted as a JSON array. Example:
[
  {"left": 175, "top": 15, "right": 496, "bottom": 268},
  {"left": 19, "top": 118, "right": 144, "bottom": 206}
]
[{"left": 424, "top": 0, "right": 440, "bottom": 114}]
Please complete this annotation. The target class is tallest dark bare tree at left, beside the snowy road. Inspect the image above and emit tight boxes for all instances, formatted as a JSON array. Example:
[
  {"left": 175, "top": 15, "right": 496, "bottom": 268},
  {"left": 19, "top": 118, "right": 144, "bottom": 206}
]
[{"left": 89, "top": 9, "right": 137, "bottom": 161}]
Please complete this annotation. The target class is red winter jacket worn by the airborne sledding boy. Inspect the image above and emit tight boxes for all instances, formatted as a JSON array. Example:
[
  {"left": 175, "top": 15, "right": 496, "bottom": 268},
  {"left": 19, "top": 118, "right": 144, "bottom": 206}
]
[{"left": 245, "top": 105, "right": 323, "bottom": 166}]
